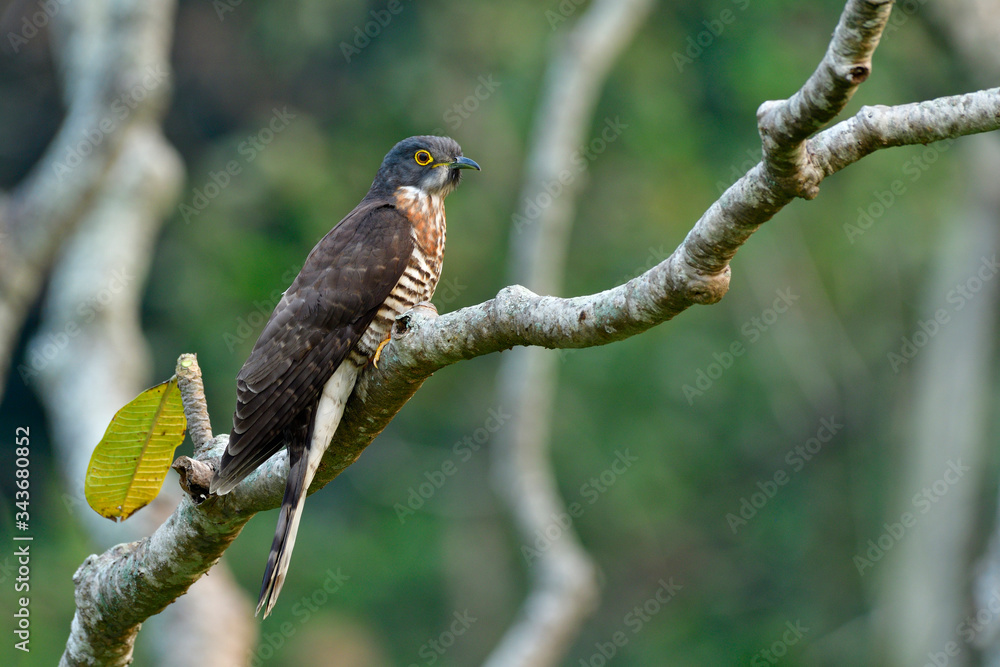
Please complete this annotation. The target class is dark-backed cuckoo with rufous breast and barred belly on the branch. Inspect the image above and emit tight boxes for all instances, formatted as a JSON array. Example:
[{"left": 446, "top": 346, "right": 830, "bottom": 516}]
[{"left": 211, "top": 136, "right": 479, "bottom": 617}]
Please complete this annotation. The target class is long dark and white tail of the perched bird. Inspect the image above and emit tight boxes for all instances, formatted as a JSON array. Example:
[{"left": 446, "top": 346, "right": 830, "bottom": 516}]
[{"left": 256, "top": 446, "right": 311, "bottom": 618}]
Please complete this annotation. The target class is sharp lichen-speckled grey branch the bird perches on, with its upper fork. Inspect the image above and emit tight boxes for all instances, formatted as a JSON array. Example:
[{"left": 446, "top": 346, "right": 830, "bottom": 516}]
[{"left": 67, "top": 0, "right": 1000, "bottom": 664}]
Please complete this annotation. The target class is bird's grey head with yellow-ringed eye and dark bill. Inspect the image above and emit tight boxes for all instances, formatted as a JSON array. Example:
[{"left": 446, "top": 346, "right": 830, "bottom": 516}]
[{"left": 372, "top": 135, "right": 479, "bottom": 197}]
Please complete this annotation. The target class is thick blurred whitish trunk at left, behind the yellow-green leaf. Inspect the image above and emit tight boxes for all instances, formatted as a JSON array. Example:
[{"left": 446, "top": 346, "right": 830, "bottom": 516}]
[{"left": 4, "top": 0, "right": 256, "bottom": 667}]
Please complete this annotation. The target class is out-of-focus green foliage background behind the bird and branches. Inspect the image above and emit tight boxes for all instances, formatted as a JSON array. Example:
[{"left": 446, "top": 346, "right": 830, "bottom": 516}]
[{"left": 0, "top": 0, "right": 992, "bottom": 667}]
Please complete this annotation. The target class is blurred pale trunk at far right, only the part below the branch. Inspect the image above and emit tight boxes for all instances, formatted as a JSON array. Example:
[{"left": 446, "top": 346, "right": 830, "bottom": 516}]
[{"left": 875, "top": 137, "right": 1000, "bottom": 666}]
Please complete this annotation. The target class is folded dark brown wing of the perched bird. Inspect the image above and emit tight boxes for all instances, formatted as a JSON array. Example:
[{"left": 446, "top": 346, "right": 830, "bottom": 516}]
[{"left": 212, "top": 200, "right": 413, "bottom": 493}]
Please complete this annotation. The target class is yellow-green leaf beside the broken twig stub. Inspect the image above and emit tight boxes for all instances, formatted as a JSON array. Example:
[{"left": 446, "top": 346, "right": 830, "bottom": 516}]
[{"left": 84, "top": 376, "right": 187, "bottom": 521}]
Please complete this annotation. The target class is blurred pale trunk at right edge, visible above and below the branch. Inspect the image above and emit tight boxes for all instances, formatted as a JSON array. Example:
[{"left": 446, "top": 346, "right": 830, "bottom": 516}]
[{"left": 877, "top": 0, "right": 1000, "bottom": 665}]
